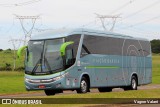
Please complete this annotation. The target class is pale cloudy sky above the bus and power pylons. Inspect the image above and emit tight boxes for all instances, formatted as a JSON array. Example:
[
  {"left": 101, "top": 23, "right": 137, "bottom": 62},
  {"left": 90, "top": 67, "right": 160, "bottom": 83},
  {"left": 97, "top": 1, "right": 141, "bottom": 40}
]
[{"left": 0, "top": 0, "right": 160, "bottom": 49}]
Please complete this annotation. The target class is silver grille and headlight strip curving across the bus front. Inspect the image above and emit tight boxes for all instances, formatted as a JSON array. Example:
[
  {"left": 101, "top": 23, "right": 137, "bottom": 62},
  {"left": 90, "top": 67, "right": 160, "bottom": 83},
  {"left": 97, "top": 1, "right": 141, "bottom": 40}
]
[{"left": 25, "top": 72, "right": 68, "bottom": 83}]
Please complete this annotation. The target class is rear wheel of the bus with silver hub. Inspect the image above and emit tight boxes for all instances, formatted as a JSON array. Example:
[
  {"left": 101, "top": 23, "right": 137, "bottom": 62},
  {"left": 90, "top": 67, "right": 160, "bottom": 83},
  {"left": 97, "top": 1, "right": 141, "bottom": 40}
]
[{"left": 123, "top": 76, "right": 138, "bottom": 91}]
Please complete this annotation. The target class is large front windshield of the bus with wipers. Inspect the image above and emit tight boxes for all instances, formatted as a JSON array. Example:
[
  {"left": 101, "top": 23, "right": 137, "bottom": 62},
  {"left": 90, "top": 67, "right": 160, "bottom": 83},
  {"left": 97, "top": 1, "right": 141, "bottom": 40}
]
[{"left": 25, "top": 38, "right": 64, "bottom": 74}]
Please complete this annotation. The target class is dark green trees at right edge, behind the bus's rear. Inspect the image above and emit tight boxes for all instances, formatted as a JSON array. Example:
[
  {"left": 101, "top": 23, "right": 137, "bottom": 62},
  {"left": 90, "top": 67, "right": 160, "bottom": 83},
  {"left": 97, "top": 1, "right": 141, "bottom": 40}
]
[{"left": 151, "top": 39, "right": 160, "bottom": 53}]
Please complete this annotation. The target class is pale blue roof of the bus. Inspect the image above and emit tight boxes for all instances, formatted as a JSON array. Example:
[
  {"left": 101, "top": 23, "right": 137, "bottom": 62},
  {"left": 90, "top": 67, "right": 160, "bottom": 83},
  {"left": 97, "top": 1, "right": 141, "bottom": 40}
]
[{"left": 31, "top": 28, "right": 148, "bottom": 41}]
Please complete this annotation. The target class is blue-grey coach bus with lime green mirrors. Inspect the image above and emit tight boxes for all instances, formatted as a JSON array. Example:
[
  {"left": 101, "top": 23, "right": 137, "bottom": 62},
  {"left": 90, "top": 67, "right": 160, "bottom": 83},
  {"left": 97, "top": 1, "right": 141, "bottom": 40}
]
[{"left": 18, "top": 28, "right": 152, "bottom": 95}]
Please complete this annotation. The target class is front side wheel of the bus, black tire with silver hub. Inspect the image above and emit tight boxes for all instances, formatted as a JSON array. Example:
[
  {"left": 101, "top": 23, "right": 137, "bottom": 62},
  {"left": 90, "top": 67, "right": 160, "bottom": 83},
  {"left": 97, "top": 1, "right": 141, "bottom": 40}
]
[{"left": 76, "top": 77, "right": 89, "bottom": 93}]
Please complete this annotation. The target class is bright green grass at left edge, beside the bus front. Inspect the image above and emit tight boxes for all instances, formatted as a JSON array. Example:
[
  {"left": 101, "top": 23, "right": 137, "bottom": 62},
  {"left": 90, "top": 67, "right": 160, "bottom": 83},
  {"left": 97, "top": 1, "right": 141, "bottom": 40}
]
[{"left": 0, "top": 71, "right": 39, "bottom": 95}]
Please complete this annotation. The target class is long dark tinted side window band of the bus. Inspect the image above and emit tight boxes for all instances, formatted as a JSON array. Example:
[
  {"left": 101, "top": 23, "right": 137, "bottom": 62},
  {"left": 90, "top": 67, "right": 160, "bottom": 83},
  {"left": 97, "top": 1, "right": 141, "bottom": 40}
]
[{"left": 81, "top": 35, "right": 150, "bottom": 57}]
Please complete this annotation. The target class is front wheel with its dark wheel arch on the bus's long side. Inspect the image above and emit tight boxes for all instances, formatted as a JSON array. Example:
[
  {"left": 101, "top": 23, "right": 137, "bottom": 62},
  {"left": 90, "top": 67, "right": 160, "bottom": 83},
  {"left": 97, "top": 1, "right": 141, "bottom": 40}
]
[{"left": 76, "top": 74, "right": 90, "bottom": 93}]
